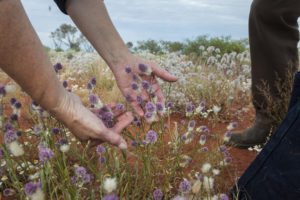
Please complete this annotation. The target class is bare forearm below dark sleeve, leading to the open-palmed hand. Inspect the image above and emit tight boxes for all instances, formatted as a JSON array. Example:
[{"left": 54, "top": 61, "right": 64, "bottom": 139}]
[{"left": 66, "top": 0, "right": 130, "bottom": 70}]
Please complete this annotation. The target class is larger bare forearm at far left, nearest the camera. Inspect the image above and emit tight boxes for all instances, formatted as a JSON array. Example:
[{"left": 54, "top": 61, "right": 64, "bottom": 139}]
[{"left": 0, "top": 0, "right": 65, "bottom": 111}]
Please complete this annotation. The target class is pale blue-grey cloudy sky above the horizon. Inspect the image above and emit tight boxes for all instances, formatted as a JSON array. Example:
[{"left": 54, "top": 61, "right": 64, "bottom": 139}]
[{"left": 21, "top": 0, "right": 252, "bottom": 47}]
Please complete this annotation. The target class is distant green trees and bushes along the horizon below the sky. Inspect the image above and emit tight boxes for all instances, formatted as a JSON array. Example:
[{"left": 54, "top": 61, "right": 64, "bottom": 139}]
[{"left": 46, "top": 24, "right": 249, "bottom": 56}]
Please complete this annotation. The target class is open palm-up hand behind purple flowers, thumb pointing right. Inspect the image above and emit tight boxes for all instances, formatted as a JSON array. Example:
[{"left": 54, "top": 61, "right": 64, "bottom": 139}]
[{"left": 111, "top": 54, "right": 177, "bottom": 116}]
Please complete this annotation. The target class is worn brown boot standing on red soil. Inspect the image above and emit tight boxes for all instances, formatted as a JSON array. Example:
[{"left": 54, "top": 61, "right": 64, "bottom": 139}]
[{"left": 225, "top": 113, "right": 272, "bottom": 149}]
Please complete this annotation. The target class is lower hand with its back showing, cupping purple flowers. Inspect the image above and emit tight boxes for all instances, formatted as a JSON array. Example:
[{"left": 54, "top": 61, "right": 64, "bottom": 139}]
[{"left": 50, "top": 92, "right": 133, "bottom": 149}]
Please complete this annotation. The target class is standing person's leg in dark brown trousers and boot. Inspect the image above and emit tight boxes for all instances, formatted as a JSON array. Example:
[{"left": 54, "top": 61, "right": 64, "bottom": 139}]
[{"left": 228, "top": 0, "right": 300, "bottom": 148}]
